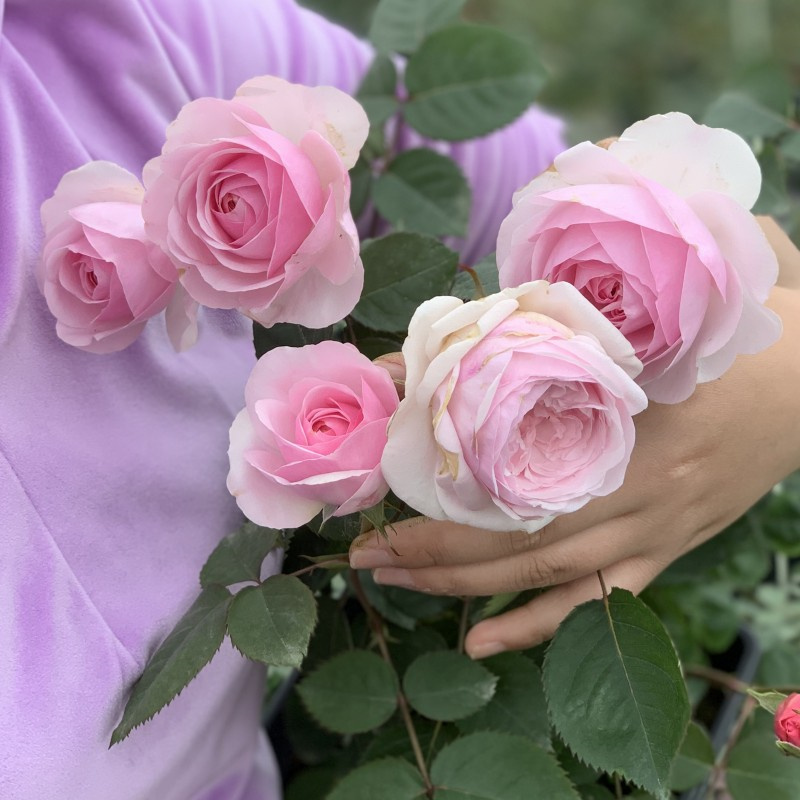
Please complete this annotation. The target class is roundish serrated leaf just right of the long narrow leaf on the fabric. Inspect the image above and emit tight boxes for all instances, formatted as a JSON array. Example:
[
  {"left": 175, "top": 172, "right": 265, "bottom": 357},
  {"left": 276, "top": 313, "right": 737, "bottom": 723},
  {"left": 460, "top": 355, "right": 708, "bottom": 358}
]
[{"left": 228, "top": 575, "right": 317, "bottom": 667}]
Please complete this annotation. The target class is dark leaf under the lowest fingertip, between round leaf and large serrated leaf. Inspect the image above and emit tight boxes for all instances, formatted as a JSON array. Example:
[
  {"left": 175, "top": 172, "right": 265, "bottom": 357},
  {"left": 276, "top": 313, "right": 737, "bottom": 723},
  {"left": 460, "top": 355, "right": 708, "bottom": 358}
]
[{"left": 456, "top": 653, "right": 550, "bottom": 748}]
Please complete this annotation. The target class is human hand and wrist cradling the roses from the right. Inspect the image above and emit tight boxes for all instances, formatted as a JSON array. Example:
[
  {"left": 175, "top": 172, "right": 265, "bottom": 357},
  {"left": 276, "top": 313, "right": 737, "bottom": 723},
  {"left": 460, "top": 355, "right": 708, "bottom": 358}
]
[{"left": 360, "top": 219, "right": 800, "bottom": 658}]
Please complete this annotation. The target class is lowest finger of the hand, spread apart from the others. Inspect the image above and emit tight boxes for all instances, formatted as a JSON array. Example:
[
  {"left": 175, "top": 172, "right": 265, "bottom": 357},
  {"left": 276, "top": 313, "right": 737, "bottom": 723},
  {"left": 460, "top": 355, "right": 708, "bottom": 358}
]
[{"left": 464, "top": 557, "right": 663, "bottom": 658}]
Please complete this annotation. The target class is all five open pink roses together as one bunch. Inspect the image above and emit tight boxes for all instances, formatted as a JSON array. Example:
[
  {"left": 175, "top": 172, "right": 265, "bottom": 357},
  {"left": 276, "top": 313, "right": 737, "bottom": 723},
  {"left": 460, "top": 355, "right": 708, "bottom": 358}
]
[{"left": 40, "top": 78, "right": 780, "bottom": 532}]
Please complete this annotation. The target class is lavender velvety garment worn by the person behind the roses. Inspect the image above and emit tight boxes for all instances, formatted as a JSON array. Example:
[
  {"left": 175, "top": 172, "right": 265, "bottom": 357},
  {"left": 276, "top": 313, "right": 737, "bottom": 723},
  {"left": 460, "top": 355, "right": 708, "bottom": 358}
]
[{"left": 0, "top": 0, "right": 563, "bottom": 800}]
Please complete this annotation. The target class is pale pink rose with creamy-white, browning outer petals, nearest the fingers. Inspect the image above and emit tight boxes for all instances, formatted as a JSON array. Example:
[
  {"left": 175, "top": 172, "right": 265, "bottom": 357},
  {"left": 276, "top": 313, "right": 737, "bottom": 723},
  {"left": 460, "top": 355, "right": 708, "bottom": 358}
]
[{"left": 382, "top": 281, "right": 647, "bottom": 532}]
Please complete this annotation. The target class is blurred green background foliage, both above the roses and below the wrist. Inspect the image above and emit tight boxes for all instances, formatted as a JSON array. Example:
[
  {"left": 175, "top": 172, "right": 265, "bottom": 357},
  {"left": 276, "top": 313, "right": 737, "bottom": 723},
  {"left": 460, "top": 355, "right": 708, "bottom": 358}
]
[{"left": 290, "top": 0, "right": 800, "bottom": 788}]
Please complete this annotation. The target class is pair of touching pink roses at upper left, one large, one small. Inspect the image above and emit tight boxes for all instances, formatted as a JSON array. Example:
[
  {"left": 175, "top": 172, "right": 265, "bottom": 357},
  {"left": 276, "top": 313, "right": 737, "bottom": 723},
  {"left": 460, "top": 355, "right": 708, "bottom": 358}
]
[{"left": 37, "top": 76, "right": 369, "bottom": 353}]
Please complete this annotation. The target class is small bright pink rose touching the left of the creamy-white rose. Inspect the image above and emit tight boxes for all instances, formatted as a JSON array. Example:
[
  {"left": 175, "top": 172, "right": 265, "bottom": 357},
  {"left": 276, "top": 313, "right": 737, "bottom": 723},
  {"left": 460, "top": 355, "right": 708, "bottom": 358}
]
[{"left": 228, "top": 342, "right": 398, "bottom": 528}]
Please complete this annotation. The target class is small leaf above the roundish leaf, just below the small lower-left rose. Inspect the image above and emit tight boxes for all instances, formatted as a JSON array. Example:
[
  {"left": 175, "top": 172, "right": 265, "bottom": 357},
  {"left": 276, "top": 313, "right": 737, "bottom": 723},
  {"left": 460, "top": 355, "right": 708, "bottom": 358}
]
[{"left": 200, "top": 521, "right": 282, "bottom": 589}]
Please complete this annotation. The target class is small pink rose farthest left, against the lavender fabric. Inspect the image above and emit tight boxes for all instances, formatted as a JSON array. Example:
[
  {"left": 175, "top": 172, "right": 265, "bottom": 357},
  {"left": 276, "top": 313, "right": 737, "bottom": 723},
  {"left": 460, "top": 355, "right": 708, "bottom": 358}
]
[{"left": 36, "top": 161, "right": 178, "bottom": 353}]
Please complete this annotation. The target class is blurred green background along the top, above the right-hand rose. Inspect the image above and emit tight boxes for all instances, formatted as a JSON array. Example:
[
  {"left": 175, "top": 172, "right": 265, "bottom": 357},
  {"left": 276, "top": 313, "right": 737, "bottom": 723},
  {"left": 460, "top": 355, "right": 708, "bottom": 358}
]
[{"left": 301, "top": 0, "right": 800, "bottom": 242}]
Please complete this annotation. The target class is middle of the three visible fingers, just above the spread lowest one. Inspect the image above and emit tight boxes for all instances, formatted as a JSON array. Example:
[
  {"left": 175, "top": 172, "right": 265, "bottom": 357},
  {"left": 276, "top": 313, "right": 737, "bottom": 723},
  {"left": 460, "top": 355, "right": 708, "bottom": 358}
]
[{"left": 364, "top": 519, "right": 641, "bottom": 595}]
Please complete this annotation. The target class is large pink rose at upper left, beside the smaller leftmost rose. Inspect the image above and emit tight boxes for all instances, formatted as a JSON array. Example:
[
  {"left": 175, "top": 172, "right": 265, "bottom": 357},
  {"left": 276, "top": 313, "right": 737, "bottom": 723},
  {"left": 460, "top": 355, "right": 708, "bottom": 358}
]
[{"left": 143, "top": 72, "right": 369, "bottom": 328}]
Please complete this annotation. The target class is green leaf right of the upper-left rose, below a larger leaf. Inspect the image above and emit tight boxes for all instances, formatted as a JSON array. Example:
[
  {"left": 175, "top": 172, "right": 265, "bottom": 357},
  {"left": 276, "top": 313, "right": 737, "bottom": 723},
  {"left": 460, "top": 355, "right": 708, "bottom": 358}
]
[{"left": 373, "top": 148, "right": 471, "bottom": 236}]
